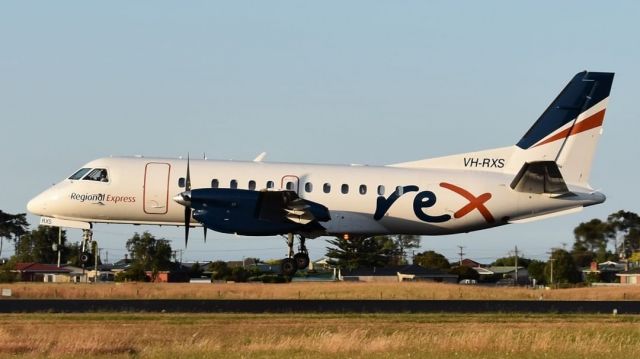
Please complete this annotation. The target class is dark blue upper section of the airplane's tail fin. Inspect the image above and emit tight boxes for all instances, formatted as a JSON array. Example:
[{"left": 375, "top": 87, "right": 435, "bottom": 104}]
[{"left": 517, "top": 71, "right": 614, "bottom": 149}]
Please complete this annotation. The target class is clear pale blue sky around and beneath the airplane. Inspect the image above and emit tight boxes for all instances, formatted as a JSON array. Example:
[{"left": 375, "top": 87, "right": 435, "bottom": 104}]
[{"left": 0, "top": 1, "right": 640, "bottom": 262}]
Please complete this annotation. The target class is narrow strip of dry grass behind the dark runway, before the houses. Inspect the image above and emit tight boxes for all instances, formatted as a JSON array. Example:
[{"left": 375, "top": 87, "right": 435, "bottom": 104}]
[{"left": 0, "top": 282, "right": 640, "bottom": 300}]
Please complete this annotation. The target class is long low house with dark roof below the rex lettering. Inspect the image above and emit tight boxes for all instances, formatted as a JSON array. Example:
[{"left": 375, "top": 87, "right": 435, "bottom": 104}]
[{"left": 338, "top": 264, "right": 458, "bottom": 283}]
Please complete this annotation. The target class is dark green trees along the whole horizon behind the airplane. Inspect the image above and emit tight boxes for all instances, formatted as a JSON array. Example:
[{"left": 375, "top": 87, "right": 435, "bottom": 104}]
[{"left": 0, "top": 210, "right": 640, "bottom": 283}]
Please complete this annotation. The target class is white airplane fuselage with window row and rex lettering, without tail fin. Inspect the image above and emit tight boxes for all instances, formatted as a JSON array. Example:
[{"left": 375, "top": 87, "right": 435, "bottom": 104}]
[{"left": 28, "top": 157, "right": 604, "bottom": 235}]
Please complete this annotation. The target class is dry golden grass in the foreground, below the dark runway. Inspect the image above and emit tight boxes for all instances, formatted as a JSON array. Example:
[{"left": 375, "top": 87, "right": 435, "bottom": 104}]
[{"left": 0, "top": 313, "right": 640, "bottom": 359}]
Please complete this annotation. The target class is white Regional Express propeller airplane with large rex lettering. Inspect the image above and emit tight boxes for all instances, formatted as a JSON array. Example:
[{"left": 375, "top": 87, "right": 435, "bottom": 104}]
[{"left": 27, "top": 71, "right": 614, "bottom": 275}]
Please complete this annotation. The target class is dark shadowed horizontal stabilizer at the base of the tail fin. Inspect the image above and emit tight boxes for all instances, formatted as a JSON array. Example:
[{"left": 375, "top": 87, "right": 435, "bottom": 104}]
[{"left": 511, "top": 161, "right": 569, "bottom": 194}]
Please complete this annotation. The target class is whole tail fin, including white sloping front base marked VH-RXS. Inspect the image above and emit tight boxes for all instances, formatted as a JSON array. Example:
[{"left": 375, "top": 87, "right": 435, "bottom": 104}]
[{"left": 389, "top": 71, "right": 613, "bottom": 184}]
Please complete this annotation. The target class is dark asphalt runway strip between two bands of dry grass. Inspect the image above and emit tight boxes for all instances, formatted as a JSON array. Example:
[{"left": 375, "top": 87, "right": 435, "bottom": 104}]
[{"left": 0, "top": 299, "right": 640, "bottom": 314}]
